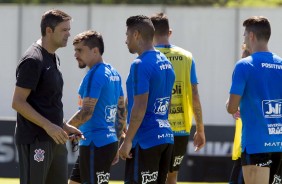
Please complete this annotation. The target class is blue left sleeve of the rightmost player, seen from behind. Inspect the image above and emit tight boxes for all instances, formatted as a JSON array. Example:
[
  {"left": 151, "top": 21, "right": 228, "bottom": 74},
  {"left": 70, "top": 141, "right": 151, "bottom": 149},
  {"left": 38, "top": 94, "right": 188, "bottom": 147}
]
[{"left": 230, "top": 62, "right": 248, "bottom": 96}]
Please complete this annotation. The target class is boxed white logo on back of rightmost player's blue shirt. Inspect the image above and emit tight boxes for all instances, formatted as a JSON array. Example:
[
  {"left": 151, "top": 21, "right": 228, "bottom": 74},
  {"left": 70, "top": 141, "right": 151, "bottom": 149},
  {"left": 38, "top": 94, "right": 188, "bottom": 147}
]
[{"left": 262, "top": 99, "right": 282, "bottom": 118}]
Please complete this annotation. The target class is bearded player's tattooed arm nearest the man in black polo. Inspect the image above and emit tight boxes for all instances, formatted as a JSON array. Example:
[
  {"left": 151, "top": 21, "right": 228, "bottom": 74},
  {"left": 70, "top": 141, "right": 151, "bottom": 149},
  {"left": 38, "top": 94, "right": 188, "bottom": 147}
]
[{"left": 67, "top": 97, "right": 98, "bottom": 127}]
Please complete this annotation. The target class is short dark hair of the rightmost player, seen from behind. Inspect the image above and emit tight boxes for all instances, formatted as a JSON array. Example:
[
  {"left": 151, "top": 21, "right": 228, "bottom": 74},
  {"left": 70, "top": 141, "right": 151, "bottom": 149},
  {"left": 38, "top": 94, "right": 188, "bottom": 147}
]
[{"left": 243, "top": 16, "right": 271, "bottom": 41}]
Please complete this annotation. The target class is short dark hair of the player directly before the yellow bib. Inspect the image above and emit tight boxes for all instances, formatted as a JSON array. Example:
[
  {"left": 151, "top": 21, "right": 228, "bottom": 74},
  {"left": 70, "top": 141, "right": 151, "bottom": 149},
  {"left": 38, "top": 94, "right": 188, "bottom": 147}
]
[{"left": 126, "top": 15, "right": 155, "bottom": 41}]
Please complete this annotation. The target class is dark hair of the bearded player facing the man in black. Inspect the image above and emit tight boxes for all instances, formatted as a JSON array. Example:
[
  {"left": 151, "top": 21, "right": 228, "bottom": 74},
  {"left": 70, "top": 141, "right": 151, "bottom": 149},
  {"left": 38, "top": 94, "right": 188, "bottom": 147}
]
[{"left": 73, "top": 30, "right": 104, "bottom": 55}]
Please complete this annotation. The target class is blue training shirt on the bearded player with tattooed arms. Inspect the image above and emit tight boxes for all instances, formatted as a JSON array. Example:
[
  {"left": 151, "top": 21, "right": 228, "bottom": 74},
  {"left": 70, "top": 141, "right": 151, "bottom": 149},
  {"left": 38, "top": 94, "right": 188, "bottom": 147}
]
[{"left": 78, "top": 63, "right": 123, "bottom": 147}]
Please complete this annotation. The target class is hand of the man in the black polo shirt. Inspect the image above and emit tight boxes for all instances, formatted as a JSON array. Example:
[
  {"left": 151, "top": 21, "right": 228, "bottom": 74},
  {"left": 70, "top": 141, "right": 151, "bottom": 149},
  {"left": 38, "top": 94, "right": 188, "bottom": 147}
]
[{"left": 43, "top": 123, "right": 69, "bottom": 144}]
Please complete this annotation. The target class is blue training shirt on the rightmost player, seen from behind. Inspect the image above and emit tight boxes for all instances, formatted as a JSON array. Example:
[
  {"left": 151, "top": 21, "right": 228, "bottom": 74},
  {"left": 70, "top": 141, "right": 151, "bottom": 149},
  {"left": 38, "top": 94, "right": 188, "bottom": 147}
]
[{"left": 230, "top": 52, "right": 282, "bottom": 154}]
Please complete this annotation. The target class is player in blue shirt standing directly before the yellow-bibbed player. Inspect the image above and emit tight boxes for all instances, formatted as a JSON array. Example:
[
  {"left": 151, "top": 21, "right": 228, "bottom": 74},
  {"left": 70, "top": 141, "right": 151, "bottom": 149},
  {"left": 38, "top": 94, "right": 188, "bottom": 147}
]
[{"left": 120, "top": 15, "right": 175, "bottom": 184}]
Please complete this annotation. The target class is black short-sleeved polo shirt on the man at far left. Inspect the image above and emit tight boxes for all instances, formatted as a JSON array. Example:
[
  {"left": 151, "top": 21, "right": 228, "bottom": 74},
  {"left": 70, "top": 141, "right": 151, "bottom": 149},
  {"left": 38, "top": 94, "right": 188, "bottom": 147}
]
[{"left": 15, "top": 43, "right": 64, "bottom": 144}]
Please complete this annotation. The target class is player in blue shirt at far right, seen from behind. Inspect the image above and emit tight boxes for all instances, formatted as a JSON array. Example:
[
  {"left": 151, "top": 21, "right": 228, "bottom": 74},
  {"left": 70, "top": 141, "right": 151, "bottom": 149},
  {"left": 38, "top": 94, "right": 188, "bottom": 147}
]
[{"left": 227, "top": 16, "right": 282, "bottom": 184}]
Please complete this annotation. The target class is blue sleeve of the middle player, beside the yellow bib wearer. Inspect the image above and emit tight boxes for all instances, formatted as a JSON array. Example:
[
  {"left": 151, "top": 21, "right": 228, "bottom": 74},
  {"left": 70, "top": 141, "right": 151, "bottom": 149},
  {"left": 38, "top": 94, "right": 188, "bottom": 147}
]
[{"left": 131, "top": 60, "right": 150, "bottom": 96}]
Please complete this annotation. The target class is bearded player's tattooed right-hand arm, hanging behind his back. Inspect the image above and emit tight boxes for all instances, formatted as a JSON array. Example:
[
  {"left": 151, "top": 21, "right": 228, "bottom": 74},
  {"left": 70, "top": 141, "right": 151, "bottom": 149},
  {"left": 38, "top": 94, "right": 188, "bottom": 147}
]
[{"left": 115, "top": 96, "right": 126, "bottom": 140}]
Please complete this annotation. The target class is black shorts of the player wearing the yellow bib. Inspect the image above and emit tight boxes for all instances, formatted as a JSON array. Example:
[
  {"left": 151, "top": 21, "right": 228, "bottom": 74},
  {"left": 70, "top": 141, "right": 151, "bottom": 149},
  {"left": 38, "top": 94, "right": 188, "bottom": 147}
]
[{"left": 169, "top": 135, "right": 189, "bottom": 172}]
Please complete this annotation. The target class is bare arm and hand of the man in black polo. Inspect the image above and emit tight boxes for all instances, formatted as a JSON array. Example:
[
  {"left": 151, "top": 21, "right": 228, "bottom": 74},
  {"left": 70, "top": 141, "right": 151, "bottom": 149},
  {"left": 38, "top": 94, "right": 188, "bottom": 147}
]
[{"left": 12, "top": 86, "right": 68, "bottom": 144}]
